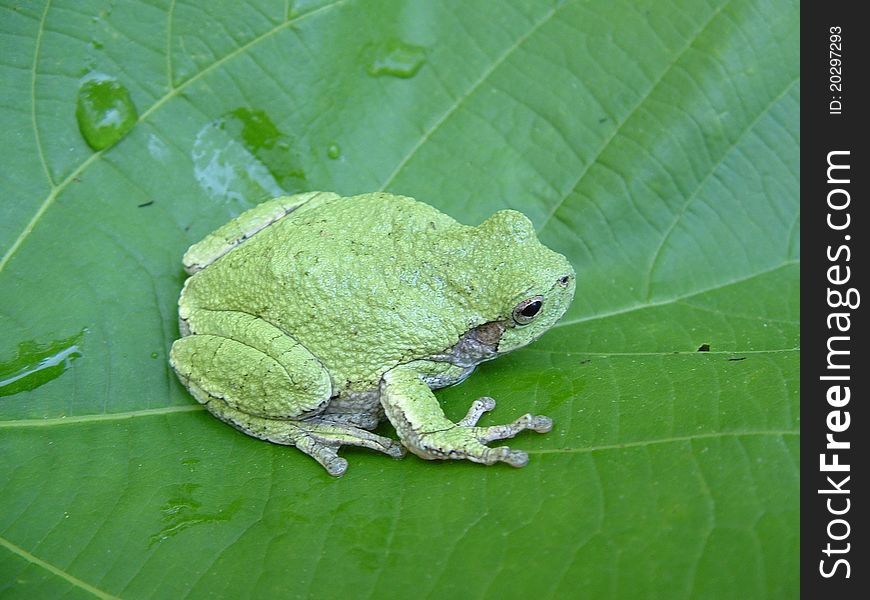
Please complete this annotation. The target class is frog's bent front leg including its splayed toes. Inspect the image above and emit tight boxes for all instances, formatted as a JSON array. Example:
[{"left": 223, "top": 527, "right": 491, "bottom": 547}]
[{"left": 381, "top": 361, "right": 553, "bottom": 467}]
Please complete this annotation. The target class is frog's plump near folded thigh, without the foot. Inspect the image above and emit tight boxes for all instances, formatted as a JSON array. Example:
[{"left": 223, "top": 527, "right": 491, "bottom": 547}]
[{"left": 170, "top": 309, "right": 332, "bottom": 420}]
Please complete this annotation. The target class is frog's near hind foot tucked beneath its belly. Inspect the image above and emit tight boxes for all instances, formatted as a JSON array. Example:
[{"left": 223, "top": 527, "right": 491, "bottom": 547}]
[{"left": 282, "top": 417, "right": 405, "bottom": 477}]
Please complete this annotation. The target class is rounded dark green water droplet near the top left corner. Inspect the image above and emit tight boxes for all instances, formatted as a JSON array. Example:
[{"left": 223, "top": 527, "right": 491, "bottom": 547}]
[{"left": 76, "top": 73, "right": 139, "bottom": 150}]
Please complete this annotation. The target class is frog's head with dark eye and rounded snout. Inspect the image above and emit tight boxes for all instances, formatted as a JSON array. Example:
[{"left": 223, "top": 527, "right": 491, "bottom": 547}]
[{"left": 480, "top": 210, "right": 576, "bottom": 354}]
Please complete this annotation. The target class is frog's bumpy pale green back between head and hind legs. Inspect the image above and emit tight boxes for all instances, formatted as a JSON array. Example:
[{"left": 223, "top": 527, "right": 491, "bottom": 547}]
[{"left": 181, "top": 193, "right": 471, "bottom": 389}]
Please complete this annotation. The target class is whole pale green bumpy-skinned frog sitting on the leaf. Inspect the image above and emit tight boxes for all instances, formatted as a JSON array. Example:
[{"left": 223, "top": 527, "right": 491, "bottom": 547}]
[{"left": 170, "top": 192, "right": 574, "bottom": 475}]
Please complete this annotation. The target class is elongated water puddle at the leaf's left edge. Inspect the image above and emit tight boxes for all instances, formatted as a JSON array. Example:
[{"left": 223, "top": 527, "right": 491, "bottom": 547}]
[{"left": 0, "top": 329, "right": 85, "bottom": 396}]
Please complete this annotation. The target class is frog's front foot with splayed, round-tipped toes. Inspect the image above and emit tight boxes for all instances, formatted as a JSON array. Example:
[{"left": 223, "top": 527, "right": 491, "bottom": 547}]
[{"left": 414, "top": 397, "right": 553, "bottom": 467}]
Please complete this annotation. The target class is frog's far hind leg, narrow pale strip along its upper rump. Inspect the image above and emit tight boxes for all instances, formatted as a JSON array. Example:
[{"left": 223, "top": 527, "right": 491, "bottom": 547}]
[{"left": 182, "top": 192, "right": 338, "bottom": 274}]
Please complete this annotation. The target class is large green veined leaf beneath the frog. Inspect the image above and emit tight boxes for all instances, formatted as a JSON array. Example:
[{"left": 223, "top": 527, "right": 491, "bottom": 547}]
[{"left": 0, "top": 0, "right": 800, "bottom": 599}]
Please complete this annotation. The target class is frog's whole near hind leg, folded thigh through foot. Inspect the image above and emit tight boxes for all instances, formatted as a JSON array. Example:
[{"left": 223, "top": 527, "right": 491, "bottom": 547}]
[{"left": 170, "top": 309, "right": 404, "bottom": 475}]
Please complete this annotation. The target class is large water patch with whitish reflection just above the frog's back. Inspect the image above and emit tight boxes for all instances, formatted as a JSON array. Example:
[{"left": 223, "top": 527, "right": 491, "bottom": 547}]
[{"left": 192, "top": 108, "right": 307, "bottom": 208}]
